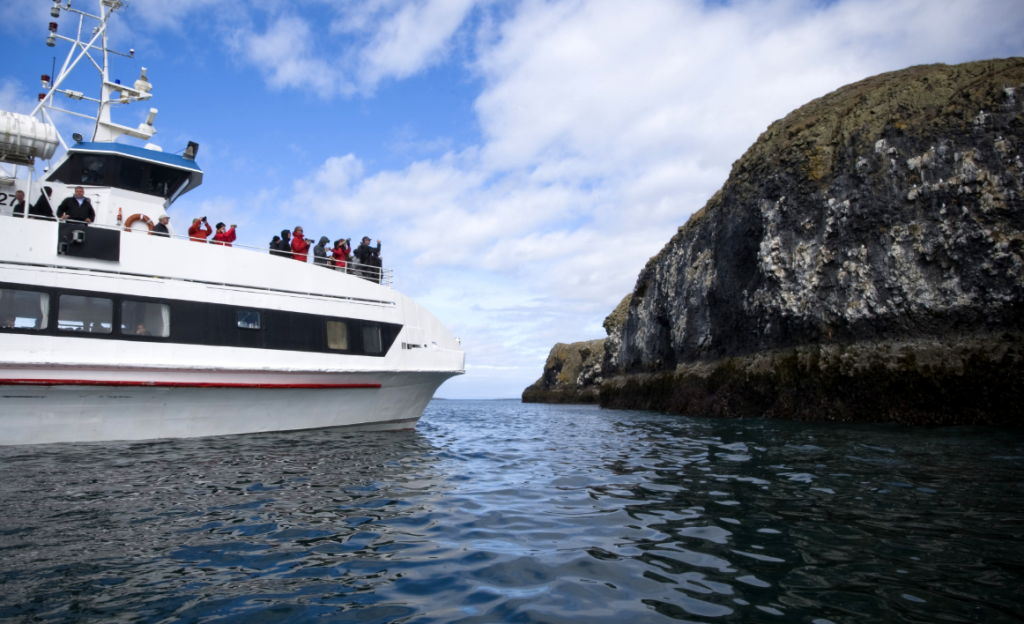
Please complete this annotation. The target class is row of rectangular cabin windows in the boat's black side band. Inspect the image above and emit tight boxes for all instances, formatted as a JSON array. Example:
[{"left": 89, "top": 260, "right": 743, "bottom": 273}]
[{"left": 0, "top": 289, "right": 383, "bottom": 353}]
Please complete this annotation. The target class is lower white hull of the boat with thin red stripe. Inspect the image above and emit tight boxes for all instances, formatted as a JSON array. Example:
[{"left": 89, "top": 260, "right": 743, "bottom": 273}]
[{"left": 0, "top": 371, "right": 453, "bottom": 445}]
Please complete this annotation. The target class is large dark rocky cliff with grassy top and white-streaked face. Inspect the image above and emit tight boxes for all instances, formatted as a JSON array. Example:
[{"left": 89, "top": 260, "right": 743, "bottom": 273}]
[{"left": 536, "top": 58, "right": 1024, "bottom": 424}]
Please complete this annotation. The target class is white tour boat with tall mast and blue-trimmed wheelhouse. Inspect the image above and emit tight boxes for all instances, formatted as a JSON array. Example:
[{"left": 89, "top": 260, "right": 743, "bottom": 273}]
[{"left": 0, "top": 0, "right": 465, "bottom": 445}]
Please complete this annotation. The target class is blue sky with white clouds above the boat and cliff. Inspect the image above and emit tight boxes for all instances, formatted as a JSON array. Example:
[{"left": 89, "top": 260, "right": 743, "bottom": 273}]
[{"left": 0, "top": 0, "right": 1024, "bottom": 399}]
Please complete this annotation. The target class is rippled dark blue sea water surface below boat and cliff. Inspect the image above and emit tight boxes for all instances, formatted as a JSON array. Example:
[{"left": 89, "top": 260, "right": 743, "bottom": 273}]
[{"left": 0, "top": 401, "right": 1024, "bottom": 624}]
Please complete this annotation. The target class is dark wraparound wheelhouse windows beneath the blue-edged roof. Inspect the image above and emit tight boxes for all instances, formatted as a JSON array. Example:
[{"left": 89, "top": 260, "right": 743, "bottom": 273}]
[{"left": 49, "top": 153, "right": 189, "bottom": 199}]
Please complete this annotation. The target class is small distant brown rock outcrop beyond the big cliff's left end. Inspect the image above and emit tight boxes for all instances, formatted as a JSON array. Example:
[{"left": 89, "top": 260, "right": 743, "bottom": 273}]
[{"left": 522, "top": 339, "right": 604, "bottom": 403}]
